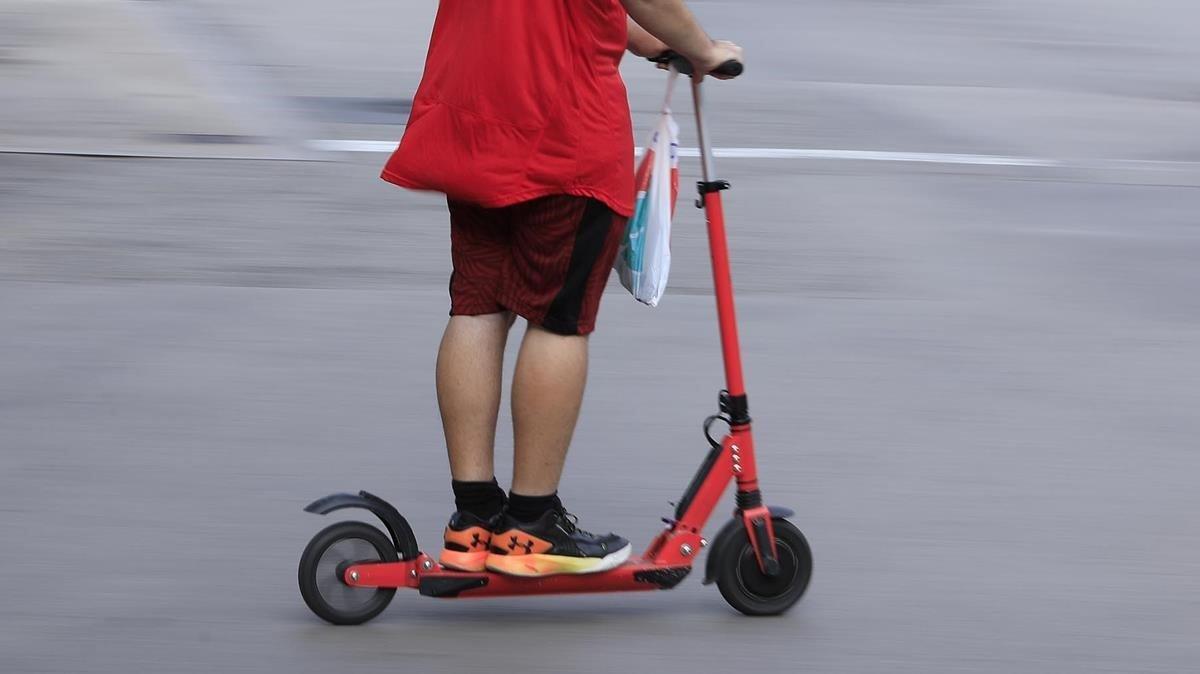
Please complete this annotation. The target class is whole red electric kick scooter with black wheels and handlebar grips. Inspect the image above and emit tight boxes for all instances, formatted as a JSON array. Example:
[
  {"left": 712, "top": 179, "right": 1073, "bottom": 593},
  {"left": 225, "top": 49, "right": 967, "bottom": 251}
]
[{"left": 299, "top": 54, "right": 812, "bottom": 625}]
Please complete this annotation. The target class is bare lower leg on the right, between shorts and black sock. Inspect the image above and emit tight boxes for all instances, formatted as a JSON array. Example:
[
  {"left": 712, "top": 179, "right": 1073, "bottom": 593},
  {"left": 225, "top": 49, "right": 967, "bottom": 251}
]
[{"left": 512, "top": 324, "right": 588, "bottom": 496}]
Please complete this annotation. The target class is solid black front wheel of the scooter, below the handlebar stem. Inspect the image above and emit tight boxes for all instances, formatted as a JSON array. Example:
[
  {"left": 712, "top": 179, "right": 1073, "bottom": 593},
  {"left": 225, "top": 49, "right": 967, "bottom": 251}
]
[{"left": 713, "top": 517, "right": 812, "bottom": 615}]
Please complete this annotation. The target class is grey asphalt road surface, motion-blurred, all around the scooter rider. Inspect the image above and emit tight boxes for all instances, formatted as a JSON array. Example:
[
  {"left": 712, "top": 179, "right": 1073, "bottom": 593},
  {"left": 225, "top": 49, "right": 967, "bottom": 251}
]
[{"left": 0, "top": 0, "right": 1200, "bottom": 674}]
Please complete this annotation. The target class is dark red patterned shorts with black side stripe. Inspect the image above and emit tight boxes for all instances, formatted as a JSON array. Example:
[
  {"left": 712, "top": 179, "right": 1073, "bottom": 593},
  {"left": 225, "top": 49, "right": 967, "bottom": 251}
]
[{"left": 449, "top": 194, "right": 625, "bottom": 335}]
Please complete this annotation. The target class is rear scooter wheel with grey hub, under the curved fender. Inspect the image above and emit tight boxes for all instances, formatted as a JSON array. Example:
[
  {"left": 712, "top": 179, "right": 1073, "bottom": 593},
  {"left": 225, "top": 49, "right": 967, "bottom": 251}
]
[{"left": 298, "top": 522, "right": 400, "bottom": 625}]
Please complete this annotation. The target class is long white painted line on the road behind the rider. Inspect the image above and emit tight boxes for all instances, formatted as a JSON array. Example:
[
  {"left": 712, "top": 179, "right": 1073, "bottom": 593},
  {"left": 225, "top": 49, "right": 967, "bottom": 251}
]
[{"left": 308, "top": 140, "right": 1063, "bottom": 168}]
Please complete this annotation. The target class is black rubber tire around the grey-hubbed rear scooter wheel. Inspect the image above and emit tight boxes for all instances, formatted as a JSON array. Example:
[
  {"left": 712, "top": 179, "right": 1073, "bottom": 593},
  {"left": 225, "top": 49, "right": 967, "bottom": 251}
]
[{"left": 298, "top": 522, "right": 400, "bottom": 625}]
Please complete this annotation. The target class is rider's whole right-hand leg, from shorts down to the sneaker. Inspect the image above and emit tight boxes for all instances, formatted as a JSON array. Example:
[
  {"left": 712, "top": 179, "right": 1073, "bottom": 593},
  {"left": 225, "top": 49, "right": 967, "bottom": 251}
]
[{"left": 486, "top": 195, "right": 630, "bottom": 576}]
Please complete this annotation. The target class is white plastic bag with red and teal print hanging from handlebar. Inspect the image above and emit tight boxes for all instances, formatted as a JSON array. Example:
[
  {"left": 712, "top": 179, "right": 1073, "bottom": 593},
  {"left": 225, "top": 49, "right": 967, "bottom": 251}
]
[{"left": 613, "top": 70, "right": 679, "bottom": 307}]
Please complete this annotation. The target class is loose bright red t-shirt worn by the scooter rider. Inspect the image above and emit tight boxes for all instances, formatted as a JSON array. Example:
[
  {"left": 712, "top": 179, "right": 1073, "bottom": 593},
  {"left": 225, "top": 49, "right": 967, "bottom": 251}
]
[{"left": 383, "top": 0, "right": 634, "bottom": 216}]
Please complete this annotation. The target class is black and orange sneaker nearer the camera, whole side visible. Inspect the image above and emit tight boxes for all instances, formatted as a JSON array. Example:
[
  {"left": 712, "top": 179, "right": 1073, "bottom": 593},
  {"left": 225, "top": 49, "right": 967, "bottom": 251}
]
[{"left": 487, "top": 510, "right": 631, "bottom": 576}]
